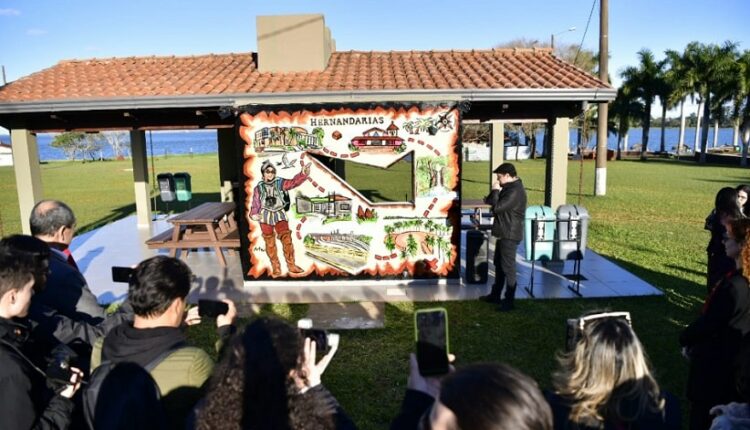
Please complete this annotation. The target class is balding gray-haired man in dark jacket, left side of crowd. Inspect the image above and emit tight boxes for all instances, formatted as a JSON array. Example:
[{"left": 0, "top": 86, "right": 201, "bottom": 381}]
[{"left": 29, "top": 200, "right": 105, "bottom": 324}]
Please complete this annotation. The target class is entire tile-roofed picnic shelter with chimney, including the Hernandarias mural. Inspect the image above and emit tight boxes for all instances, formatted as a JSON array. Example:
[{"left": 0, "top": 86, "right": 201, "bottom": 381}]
[{"left": 0, "top": 15, "right": 616, "bottom": 288}]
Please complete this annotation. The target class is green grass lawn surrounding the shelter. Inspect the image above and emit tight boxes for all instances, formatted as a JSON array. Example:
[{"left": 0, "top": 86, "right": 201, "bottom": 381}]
[{"left": 0, "top": 155, "right": 750, "bottom": 429}]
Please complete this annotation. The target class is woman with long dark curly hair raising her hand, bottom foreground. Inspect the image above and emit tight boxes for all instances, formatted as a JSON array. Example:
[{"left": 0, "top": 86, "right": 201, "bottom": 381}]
[{"left": 195, "top": 318, "right": 355, "bottom": 430}]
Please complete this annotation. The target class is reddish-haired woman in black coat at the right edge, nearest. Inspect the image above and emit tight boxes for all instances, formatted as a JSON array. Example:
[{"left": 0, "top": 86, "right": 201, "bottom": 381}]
[{"left": 680, "top": 218, "right": 750, "bottom": 429}]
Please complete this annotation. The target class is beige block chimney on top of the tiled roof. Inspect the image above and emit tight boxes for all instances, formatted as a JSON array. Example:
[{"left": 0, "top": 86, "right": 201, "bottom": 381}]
[{"left": 256, "top": 14, "right": 336, "bottom": 73}]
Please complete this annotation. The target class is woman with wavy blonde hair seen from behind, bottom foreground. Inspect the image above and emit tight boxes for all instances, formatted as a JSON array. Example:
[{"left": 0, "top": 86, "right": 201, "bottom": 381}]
[{"left": 547, "top": 317, "right": 680, "bottom": 430}]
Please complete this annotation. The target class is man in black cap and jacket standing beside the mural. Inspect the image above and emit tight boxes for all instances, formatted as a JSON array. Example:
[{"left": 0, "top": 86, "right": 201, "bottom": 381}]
[{"left": 480, "top": 163, "right": 526, "bottom": 311}]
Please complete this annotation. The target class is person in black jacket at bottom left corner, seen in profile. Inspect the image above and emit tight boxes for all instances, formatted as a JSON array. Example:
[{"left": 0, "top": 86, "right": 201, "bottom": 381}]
[{"left": 0, "top": 240, "right": 82, "bottom": 429}]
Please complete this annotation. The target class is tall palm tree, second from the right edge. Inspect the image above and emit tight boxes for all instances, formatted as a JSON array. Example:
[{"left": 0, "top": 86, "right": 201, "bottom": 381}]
[{"left": 685, "top": 41, "right": 738, "bottom": 163}]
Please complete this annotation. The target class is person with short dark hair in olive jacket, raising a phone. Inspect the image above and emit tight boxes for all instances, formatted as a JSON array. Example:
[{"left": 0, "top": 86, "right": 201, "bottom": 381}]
[{"left": 91, "top": 255, "right": 237, "bottom": 428}]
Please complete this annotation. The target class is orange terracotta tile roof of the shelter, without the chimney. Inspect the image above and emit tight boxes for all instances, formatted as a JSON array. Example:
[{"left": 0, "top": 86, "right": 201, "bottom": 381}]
[{"left": 0, "top": 49, "right": 611, "bottom": 104}]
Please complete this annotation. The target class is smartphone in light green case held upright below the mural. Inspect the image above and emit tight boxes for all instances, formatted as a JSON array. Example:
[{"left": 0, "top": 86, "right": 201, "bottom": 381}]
[{"left": 414, "top": 308, "right": 449, "bottom": 376}]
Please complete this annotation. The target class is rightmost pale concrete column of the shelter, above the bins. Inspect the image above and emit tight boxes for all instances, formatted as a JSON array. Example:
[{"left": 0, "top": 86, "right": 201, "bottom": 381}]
[{"left": 544, "top": 118, "right": 570, "bottom": 210}]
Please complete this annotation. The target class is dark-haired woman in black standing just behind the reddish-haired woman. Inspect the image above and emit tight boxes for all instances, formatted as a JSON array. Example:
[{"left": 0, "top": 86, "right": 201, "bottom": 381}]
[{"left": 704, "top": 187, "right": 742, "bottom": 291}]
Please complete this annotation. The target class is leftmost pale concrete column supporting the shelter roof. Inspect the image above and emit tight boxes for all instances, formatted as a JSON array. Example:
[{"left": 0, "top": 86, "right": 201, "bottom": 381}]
[{"left": 10, "top": 129, "right": 42, "bottom": 234}]
